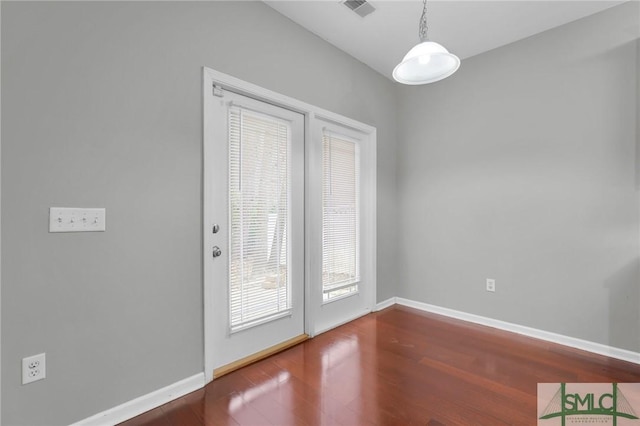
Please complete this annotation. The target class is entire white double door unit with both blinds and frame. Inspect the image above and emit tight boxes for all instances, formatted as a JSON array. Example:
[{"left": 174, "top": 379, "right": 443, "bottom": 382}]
[{"left": 203, "top": 68, "right": 376, "bottom": 381}]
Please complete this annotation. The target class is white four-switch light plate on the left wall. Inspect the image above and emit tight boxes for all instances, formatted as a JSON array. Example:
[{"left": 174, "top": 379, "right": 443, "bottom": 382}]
[{"left": 49, "top": 207, "right": 107, "bottom": 232}]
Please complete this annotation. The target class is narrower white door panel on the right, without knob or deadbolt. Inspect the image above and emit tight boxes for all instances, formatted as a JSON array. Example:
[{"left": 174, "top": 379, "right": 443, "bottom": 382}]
[{"left": 308, "top": 118, "right": 375, "bottom": 334}]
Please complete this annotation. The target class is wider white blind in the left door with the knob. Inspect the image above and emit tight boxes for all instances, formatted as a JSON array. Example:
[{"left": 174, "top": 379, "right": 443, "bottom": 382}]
[{"left": 229, "top": 107, "right": 291, "bottom": 331}]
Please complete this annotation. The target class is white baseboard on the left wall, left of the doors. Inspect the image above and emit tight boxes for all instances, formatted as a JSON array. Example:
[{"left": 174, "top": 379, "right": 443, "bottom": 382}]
[{"left": 71, "top": 373, "right": 205, "bottom": 426}]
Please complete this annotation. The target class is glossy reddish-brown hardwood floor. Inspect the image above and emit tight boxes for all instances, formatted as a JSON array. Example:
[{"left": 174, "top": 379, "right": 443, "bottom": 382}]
[{"left": 122, "top": 305, "right": 640, "bottom": 426}]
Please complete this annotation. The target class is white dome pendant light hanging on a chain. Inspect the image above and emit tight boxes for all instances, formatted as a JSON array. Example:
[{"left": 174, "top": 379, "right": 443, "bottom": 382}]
[{"left": 393, "top": 0, "right": 460, "bottom": 85}]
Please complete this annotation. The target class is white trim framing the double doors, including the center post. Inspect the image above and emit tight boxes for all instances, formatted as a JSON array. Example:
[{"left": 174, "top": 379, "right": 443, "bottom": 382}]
[{"left": 202, "top": 67, "right": 376, "bottom": 383}]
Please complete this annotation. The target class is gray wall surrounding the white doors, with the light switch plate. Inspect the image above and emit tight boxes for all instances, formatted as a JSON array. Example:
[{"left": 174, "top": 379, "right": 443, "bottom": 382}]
[{"left": 1, "top": 1, "right": 396, "bottom": 425}]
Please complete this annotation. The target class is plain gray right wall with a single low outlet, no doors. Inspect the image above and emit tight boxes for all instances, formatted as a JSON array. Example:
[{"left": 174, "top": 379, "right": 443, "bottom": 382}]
[{"left": 398, "top": 2, "right": 640, "bottom": 351}]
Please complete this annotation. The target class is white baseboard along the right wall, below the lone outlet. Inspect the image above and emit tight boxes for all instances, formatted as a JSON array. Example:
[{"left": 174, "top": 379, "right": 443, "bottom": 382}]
[{"left": 396, "top": 297, "right": 640, "bottom": 364}]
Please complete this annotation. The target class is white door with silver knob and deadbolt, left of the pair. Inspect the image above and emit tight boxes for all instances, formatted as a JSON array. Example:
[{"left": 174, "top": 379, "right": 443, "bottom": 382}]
[{"left": 205, "top": 91, "right": 304, "bottom": 375}]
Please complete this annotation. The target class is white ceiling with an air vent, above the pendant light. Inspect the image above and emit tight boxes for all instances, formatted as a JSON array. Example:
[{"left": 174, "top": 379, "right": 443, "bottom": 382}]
[{"left": 264, "top": 0, "right": 623, "bottom": 78}]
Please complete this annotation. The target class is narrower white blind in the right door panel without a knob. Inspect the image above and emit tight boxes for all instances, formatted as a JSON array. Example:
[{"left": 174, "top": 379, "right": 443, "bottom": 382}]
[{"left": 322, "top": 131, "right": 360, "bottom": 301}]
